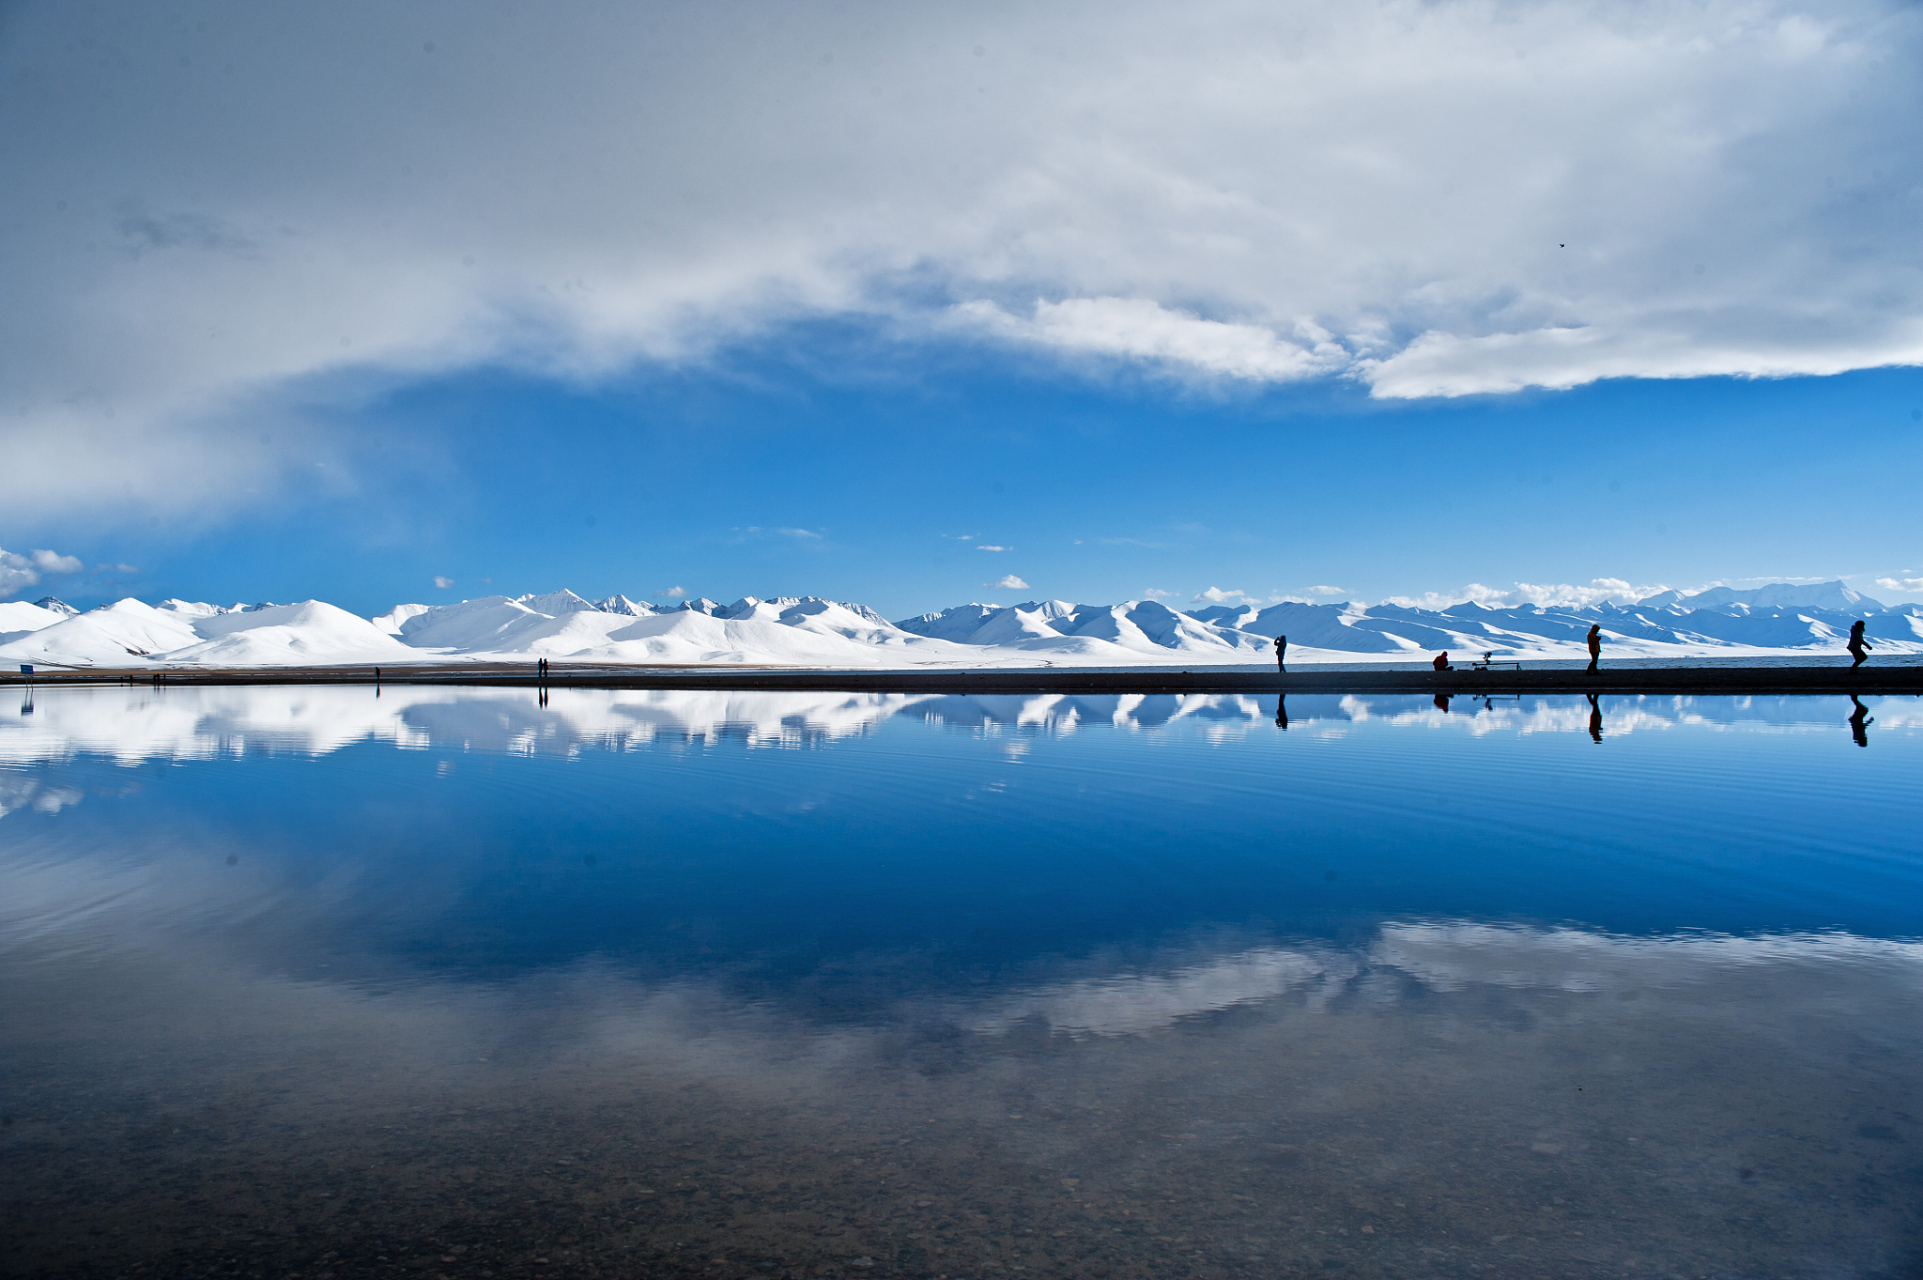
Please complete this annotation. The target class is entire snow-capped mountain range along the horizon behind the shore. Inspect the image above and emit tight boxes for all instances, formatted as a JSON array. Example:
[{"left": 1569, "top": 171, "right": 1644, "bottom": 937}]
[{"left": 0, "top": 582, "right": 1923, "bottom": 669}]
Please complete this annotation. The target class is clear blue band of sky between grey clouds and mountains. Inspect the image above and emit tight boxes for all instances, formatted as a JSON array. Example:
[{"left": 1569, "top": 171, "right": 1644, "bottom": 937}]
[{"left": 22, "top": 336, "right": 1923, "bottom": 617}]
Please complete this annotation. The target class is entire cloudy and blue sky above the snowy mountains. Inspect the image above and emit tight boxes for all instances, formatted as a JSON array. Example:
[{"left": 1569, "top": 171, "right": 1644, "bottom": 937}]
[{"left": 11, "top": 2, "right": 1923, "bottom": 617}]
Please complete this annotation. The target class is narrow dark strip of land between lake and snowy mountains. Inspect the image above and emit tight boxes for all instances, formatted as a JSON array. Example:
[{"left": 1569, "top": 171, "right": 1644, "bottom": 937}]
[{"left": 0, "top": 663, "right": 1923, "bottom": 696}]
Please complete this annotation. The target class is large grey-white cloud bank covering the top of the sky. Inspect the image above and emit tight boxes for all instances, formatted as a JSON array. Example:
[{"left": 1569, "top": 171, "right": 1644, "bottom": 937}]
[{"left": 0, "top": 0, "right": 1923, "bottom": 517}]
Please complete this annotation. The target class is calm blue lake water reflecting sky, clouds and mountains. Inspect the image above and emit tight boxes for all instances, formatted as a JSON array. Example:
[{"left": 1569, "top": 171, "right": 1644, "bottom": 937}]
[{"left": 0, "top": 686, "right": 1923, "bottom": 1280}]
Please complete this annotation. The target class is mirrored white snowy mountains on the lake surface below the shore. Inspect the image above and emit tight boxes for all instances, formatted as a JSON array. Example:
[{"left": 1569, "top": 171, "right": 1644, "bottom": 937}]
[{"left": 0, "top": 684, "right": 1923, "bottom": 763}]
